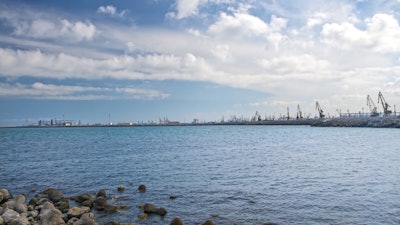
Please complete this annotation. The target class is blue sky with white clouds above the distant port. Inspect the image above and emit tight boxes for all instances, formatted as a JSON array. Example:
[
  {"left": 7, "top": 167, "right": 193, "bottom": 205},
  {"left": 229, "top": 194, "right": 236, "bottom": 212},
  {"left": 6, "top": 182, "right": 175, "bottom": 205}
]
[{"left": 0, "top": 0, "right": 400, "bottom": 126}]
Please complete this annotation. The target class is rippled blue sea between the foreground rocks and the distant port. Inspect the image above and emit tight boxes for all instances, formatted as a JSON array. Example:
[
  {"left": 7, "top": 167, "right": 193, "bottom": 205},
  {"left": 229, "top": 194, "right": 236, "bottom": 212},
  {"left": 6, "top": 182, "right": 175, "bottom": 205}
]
[{"left": 0, "top": 125, "right": 400, "bottom": 225}]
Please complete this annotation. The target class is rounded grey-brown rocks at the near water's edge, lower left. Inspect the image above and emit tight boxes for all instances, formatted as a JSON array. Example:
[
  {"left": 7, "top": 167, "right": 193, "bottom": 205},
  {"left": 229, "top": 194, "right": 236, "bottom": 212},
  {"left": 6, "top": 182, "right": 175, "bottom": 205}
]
[{"left": 0, "top": 185, "right": 219, "bottom": 225}]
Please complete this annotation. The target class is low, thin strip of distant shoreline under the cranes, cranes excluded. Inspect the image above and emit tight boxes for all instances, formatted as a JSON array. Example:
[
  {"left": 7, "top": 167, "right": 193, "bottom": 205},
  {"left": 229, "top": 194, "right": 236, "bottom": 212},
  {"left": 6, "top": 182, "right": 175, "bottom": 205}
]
[{"left": 0, "top": 116, "right": 400, "bottom": 128}]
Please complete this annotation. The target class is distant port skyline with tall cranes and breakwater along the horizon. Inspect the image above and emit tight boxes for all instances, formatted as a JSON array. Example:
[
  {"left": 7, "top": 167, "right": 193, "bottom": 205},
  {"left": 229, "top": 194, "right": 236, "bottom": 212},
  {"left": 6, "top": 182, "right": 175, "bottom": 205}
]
[{"left": 30, "top": 92, "right": 400, "bottom": 128}]
